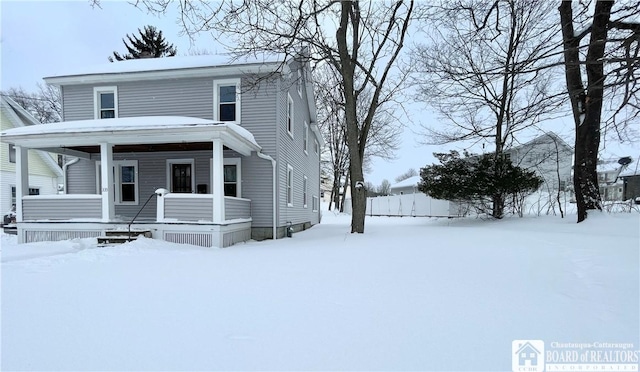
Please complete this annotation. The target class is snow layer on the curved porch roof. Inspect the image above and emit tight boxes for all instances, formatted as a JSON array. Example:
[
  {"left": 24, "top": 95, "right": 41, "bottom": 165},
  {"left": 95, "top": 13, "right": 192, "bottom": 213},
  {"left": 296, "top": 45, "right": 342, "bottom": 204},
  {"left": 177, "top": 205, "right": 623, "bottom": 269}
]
[{"left": 1, "top": 116, "right": 259, "bottom": 147}]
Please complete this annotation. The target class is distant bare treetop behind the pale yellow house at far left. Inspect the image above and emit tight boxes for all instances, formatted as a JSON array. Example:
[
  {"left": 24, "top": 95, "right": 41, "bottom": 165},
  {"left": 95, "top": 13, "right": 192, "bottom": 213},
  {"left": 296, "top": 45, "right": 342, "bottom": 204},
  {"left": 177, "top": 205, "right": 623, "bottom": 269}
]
[{"left": 2, "top": 83, "right": 62, "bottom": 123}]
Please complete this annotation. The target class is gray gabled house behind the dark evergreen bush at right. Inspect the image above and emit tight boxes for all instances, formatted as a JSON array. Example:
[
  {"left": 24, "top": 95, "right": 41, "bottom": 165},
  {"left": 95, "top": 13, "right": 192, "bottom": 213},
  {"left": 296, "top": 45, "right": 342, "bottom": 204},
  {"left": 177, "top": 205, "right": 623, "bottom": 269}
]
[{"left": 504, "top": 132, "right": 573, "bottom": 191}]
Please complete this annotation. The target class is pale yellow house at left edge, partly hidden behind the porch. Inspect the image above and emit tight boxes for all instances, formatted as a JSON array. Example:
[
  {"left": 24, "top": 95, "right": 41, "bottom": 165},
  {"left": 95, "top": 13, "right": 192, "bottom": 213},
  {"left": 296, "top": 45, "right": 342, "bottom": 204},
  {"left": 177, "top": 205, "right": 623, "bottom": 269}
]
[{"left": 0, "top": 96, "right": 63, "bottom": 215}]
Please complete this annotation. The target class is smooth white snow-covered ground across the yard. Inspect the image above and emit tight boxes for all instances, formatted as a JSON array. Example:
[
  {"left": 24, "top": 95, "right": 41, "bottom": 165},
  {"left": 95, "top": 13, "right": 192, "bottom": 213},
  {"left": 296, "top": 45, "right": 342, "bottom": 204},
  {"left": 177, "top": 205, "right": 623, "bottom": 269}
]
[{"left": 0, "top": 208, "right": 640, "bottom": 371}]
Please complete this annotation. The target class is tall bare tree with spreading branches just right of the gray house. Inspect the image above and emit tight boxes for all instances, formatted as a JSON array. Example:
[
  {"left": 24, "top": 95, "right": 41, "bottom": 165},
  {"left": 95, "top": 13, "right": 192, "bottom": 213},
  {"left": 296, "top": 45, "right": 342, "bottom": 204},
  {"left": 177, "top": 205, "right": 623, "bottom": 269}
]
[{"left": 110, "top": 0, "right": 414, "bottom": 233}]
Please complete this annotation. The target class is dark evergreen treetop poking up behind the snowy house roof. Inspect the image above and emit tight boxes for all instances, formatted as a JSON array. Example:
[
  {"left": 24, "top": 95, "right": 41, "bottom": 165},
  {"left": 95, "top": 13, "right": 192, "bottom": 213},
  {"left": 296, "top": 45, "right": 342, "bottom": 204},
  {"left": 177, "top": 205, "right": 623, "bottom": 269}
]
[{"left": 109, "top": 26, "right": 178, "bottom": 62}]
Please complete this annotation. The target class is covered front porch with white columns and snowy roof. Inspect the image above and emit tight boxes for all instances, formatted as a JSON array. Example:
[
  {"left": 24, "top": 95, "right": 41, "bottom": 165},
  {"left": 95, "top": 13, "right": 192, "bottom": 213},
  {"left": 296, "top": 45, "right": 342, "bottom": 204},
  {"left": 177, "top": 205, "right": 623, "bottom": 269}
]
[{"left": 2, "top": 117, "right": 260, "bottom": 247}]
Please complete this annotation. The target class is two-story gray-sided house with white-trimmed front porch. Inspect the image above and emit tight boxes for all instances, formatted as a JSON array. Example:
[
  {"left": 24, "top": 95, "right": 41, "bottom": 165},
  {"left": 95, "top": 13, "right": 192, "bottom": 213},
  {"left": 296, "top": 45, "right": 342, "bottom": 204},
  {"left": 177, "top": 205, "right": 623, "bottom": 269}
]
[{"left": 2, "top": 56, "right": 323, "bottom": 247}]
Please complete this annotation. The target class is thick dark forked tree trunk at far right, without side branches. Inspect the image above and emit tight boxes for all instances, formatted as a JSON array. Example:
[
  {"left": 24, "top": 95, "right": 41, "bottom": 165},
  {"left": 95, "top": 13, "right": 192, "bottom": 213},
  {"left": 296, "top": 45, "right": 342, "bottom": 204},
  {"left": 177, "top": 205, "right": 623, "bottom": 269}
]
[{"left": 559, "top": 1, "right": 613, "bottom": 222}]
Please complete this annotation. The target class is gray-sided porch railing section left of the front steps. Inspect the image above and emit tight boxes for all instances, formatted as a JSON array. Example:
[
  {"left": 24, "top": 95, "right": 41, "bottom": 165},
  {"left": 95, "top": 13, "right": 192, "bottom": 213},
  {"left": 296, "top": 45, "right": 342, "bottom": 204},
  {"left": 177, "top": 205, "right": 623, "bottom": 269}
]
[{"left": 22, "top": 194, "right": 102, "bottom": 221}]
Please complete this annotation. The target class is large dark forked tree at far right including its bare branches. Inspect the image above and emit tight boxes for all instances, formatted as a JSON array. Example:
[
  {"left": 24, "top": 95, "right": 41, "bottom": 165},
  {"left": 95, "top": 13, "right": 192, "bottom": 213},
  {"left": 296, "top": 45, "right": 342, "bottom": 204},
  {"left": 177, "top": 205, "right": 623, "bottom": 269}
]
[{"left": 559, "top": 1, "right": 640, "bottom": 222}]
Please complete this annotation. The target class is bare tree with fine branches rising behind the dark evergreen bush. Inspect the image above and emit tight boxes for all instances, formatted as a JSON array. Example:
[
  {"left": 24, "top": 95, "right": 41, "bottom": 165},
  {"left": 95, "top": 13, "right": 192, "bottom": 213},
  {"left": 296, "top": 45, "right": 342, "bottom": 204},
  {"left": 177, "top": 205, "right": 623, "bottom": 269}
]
[{"left": 412, "top": 0, "right": 562, "bottom": 218}]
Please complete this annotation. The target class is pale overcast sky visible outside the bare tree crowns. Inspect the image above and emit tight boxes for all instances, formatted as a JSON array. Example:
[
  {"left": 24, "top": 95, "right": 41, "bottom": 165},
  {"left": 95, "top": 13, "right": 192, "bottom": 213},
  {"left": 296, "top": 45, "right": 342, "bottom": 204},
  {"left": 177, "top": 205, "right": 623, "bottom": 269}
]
[{"left": 0, "top": 0, "right": 637, "bottom": 186}]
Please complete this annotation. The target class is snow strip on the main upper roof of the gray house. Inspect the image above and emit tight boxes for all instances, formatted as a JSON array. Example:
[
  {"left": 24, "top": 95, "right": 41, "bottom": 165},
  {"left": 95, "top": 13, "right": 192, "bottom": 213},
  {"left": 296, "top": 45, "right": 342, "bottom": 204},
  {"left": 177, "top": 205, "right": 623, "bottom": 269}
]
[{"left": 45, "top": 54, "right": 283, "bottom": 79}]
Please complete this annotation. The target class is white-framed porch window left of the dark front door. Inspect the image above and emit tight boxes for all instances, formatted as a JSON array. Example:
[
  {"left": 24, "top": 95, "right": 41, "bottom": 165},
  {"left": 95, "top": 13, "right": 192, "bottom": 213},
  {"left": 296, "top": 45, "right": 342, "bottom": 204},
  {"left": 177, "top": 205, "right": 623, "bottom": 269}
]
[{"left": 96, "top": 160, "right": 138, "bottom": 205}]
